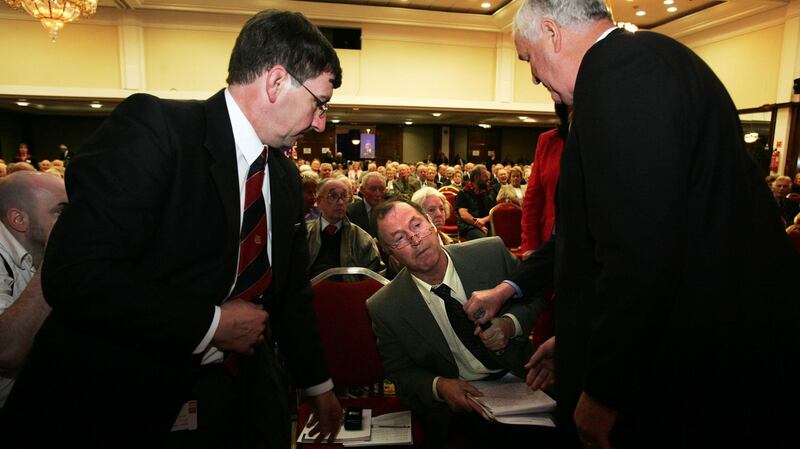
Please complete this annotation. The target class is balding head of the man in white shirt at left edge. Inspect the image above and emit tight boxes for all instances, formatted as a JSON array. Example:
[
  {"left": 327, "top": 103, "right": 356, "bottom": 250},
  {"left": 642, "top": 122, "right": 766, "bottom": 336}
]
[{"left": 0, "top": 171, "right": 67, "bottom": 266}]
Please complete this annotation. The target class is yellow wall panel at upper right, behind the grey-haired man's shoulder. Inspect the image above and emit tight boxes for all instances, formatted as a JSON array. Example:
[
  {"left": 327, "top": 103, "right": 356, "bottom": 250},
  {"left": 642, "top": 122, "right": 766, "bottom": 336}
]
[{"left": 692, "top": 25, "right": 783, "bottom": 109}]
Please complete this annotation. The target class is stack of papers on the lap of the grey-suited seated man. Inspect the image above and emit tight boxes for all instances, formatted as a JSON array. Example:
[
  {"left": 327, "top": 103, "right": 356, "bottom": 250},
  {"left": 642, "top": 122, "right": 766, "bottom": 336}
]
[{"left": 467, "top": 374, "right": 556, "bottom": 427}]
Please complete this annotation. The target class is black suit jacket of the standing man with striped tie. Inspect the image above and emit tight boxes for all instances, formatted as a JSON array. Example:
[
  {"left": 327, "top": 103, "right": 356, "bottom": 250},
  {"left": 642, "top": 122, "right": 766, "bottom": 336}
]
[{"left": 4, "top": 91, "right": 329, "bottom": 447}]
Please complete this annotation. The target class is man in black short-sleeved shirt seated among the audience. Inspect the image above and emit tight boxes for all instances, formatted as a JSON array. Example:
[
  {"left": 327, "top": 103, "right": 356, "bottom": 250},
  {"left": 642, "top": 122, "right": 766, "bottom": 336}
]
[{"left": 456, "top": 164, "right": 495, "bottom": 240}]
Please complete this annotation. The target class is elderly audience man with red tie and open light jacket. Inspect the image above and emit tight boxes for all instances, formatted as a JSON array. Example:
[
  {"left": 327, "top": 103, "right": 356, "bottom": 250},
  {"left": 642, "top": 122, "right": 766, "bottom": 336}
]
[{"left": 306, "top": 176, "right": 386, "bottom": 277}]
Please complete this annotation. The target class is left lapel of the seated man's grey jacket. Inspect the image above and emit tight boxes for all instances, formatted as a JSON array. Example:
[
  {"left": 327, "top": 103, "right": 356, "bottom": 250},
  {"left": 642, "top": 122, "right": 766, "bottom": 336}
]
[{"left": 396, "top": 270, "right": 456, "bottom": 366}]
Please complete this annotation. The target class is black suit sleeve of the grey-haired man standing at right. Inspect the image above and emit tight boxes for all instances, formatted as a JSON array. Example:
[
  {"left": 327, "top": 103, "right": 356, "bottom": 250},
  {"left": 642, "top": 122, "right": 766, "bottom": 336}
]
[{"left": 573, "top": 40, "right": 698, "bottom": 409}]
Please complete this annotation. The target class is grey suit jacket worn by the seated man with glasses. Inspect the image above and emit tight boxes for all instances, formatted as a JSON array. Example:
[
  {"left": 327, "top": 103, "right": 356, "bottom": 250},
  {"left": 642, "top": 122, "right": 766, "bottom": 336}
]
[{"left": 367, "top": 237, "right": 543, "bottom": 415}]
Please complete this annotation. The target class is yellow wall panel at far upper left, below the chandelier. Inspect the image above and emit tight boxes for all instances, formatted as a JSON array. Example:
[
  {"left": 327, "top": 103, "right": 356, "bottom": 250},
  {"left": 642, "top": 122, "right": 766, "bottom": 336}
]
[{"left": 0, "top": 17, "right": 120, "bottom": 88}]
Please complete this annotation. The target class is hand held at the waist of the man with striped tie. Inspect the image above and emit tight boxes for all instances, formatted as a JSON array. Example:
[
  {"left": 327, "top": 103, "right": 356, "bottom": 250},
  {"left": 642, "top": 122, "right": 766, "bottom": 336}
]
[{"left": 211, "top": 298, "right": 269, "bottom": 355}]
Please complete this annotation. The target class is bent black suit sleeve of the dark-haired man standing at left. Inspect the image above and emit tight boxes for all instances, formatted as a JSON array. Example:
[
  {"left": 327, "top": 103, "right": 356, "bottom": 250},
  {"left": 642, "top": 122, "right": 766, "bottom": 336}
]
[{"left": 42, "top": 95, "right": 215, "bottom": 356}]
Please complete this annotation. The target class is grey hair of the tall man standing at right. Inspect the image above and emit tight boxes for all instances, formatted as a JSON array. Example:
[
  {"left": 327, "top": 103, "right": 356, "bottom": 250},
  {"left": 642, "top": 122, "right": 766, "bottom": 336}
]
[{"left": 514, "top": 0, "right": 613, "bottom": 41}]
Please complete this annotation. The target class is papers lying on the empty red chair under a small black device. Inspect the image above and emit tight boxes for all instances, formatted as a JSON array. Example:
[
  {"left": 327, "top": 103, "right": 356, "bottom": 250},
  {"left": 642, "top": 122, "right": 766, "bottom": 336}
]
[{"left": 297, "top": 409, "right": 413, "bottom": 447}]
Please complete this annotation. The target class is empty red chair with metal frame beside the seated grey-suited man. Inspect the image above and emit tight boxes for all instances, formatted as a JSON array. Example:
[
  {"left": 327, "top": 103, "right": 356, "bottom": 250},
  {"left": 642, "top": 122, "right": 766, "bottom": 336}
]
[{"left": 297, "top": 267, "right": 424, "bottom": 449}]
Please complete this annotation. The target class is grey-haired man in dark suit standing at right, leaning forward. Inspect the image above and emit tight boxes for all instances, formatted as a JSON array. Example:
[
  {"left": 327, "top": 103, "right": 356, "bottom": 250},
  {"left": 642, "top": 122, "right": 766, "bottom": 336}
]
[{"left": 467, "top": 0, "right": 800, "bottom": 448}]
